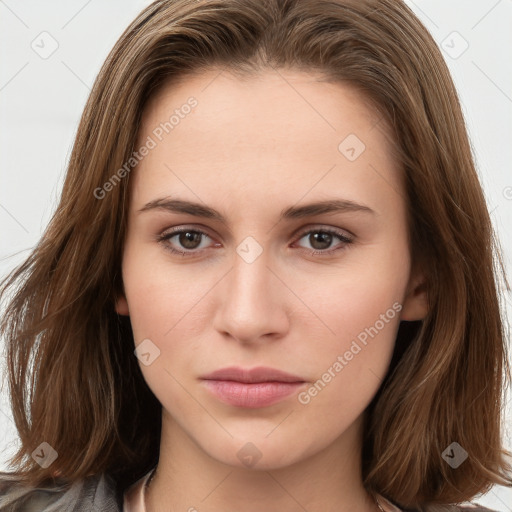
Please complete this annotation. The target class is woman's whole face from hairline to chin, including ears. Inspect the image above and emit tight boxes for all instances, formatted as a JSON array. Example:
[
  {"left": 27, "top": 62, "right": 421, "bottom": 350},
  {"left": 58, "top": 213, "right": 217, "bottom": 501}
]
[{"left": 116, "top": 70, "right": 425, "bottom": 468}]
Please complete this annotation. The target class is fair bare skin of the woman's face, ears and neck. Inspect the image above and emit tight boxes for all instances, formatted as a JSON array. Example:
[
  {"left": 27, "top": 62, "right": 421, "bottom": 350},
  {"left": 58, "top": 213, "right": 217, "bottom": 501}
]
[{"left": 116, "top": 69, "right": 426, "bottom": 512}]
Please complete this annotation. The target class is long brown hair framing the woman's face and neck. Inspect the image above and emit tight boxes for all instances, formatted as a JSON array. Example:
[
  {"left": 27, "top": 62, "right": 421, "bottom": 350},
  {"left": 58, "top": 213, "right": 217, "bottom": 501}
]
[{"left": 0, "top": 0, "right": 512, "bottom": 507}]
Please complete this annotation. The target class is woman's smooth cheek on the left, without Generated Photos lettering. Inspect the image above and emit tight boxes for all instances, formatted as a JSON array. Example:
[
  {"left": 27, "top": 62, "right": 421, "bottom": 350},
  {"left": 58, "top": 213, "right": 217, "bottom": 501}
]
[{"left": 123, "top": 258, "right": 204, "bottom": 410}]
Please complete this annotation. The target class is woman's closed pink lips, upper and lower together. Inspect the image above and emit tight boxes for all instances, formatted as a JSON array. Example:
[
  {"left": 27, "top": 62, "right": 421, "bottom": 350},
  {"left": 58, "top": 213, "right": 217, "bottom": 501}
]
[{"left": 201, "top": 366, "right": 306, "bottom": 409}]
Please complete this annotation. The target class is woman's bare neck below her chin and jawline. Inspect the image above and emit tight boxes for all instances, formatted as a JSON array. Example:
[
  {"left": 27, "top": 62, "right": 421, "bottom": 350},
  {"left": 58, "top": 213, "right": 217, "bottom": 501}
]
[{"left": 146, "top": 410, "right": 380, "bottom": 512}]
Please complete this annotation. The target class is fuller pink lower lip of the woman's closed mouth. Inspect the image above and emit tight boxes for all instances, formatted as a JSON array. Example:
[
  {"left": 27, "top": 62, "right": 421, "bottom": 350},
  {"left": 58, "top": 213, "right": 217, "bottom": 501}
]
[{"left": 203, "top": 380, "right": 305, "bottom": 409}]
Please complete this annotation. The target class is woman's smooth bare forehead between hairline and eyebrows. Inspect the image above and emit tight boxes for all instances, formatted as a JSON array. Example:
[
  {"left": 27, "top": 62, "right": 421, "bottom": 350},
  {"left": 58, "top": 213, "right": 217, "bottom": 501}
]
[{"left": 133, "top": 69, "right": 400, "bottom": 214}]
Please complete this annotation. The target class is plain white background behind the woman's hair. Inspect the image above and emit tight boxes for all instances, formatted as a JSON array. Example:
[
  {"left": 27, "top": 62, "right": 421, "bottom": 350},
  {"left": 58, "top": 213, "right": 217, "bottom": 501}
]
[{"left": 0, "top": 0, "right": 512, "bottom": 512}]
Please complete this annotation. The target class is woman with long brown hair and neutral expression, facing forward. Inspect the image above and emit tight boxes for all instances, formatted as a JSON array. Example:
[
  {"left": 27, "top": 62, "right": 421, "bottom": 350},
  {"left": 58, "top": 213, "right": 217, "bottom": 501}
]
[{"left": 0, "top": 0, "right": 512, "bottom": 512}]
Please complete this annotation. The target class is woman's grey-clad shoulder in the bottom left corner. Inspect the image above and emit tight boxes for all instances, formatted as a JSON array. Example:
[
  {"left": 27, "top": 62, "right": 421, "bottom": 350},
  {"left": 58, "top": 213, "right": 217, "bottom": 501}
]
[{"left": 0, "top": 472, "right": 122, "bottom": 512}]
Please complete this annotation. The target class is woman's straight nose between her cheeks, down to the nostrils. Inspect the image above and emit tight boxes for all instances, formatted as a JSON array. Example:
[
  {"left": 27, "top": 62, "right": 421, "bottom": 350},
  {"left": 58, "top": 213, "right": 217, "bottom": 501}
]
[{"left": 214, "top": 247, "right": 291, "bottom": 344}]
